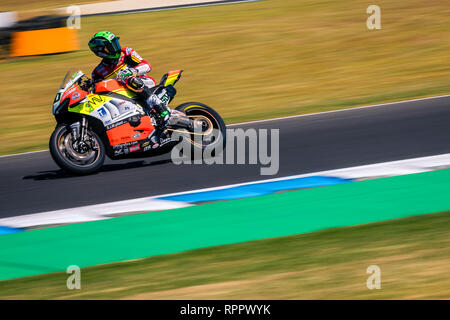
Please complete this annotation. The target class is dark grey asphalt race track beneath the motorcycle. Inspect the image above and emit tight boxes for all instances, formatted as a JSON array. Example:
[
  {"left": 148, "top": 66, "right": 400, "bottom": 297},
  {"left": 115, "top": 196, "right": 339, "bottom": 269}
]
[{"left": 0, "top": 97, "right": 450, "bottom": 218}]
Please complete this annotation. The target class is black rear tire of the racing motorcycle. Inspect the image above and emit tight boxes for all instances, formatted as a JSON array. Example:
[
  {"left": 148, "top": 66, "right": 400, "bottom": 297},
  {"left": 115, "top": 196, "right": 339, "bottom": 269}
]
[{"left": 175, "top": 102, "right": 227, "bottom": 156}]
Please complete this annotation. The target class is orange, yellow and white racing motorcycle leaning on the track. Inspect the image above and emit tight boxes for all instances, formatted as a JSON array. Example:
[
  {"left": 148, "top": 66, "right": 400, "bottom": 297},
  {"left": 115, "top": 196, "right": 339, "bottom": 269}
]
[{"left": 49, "top": 70, "right": 226, "bottom": 174}]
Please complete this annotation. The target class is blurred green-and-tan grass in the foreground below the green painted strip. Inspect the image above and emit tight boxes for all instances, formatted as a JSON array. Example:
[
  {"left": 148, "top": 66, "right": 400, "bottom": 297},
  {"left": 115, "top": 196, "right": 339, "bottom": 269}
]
[{"left": 0, "top": 212, "right": 450, "bottom": 299}]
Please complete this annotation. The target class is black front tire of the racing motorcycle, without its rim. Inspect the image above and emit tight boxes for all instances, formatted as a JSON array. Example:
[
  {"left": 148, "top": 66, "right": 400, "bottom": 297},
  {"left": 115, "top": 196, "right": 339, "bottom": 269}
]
[{"left": 49, "top": 125, "right": 106, "bottom": 175}]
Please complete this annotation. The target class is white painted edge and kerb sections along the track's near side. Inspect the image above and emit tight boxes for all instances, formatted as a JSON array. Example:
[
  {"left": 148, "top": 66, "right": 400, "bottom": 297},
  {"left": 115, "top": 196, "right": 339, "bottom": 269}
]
[{"left": 0, "top": 153, "right": 450, "bottom": 228}]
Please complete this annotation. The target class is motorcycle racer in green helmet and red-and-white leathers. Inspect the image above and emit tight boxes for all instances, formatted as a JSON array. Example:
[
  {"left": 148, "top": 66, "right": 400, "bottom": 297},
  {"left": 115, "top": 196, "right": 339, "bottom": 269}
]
[{"left": 88, "top": 31, "right": 172, "bottom": 143}]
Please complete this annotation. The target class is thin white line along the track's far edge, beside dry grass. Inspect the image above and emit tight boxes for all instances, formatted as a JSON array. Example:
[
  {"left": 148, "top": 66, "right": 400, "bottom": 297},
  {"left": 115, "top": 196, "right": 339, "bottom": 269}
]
[{"left": 0, "top": 94, "right": 450, "bottom": 159}]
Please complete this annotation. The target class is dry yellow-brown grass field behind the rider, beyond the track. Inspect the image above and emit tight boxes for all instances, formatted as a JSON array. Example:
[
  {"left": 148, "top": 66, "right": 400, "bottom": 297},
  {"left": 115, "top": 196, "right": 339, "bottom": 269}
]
[{"left": 0, "top": 0, "right": 450, "bottom": 154}]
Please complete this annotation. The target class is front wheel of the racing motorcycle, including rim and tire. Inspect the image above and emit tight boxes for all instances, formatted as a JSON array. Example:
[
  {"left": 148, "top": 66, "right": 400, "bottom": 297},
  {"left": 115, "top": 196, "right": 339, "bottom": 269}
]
[{"left": 49, "top": 124, "right": 105, "bottom": 175}]
